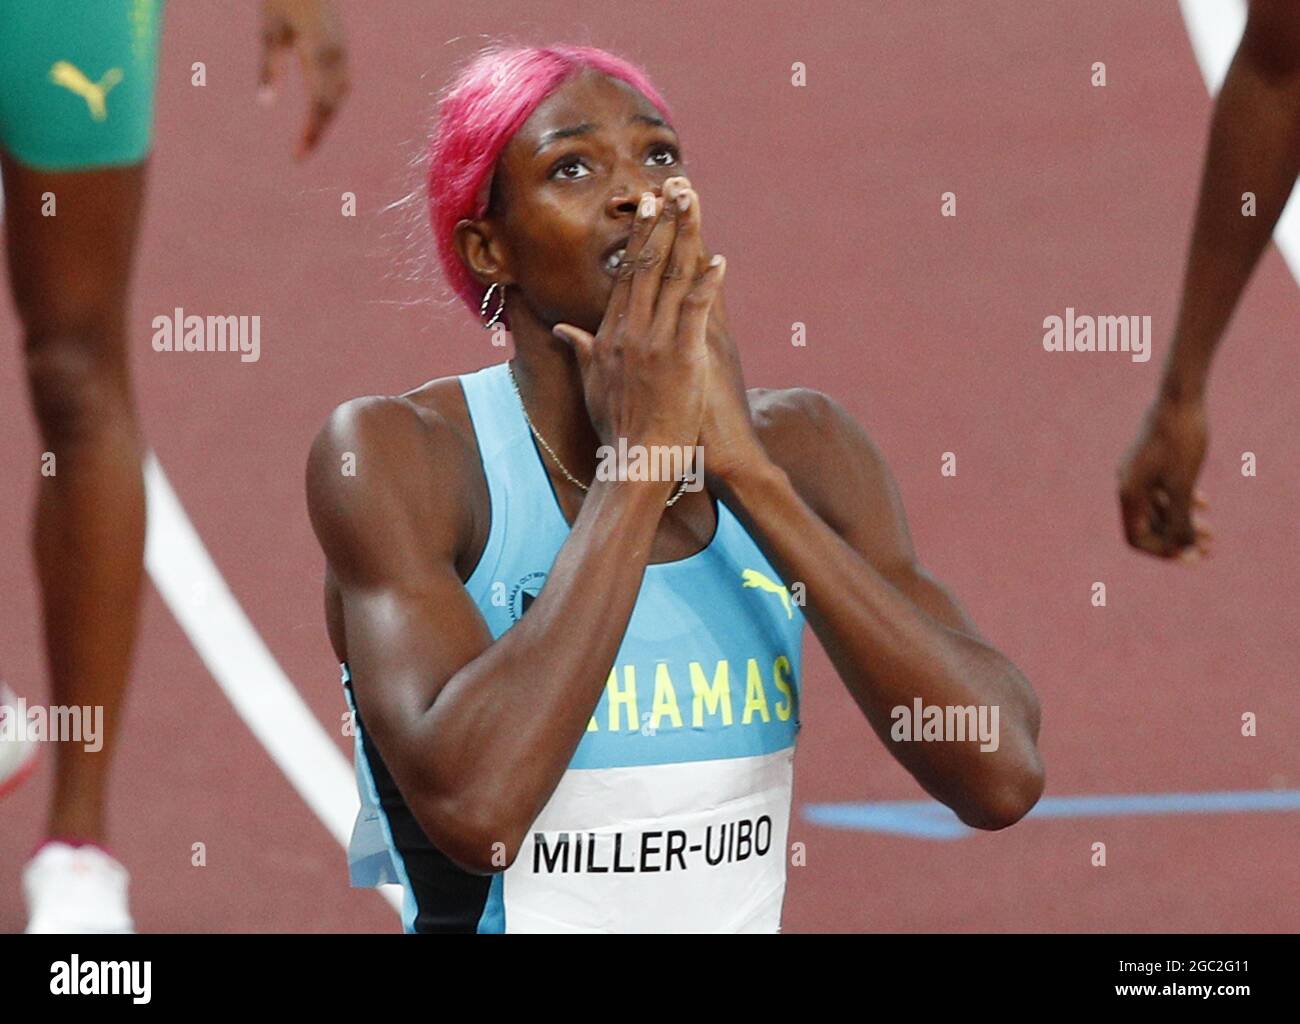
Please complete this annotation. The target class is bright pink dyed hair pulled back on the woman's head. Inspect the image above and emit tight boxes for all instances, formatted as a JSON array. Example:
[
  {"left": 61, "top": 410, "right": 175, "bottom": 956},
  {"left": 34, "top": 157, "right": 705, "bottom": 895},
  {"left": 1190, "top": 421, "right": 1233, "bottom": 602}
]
[{"left": 428, "top": 44, "right": 672, "bottom": 317}]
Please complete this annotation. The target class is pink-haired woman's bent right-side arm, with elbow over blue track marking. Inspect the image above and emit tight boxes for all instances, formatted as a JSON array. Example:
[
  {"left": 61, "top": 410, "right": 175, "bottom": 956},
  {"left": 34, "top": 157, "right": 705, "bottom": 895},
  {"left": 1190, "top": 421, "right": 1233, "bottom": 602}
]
[{"left": 702, "top": 337, "right": 1044, "bottom": 829}]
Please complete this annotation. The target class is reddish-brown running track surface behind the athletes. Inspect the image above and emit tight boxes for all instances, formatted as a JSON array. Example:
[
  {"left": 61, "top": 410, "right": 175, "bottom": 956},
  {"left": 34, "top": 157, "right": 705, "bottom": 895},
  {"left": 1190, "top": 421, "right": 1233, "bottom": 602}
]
[{"left": 0, "top": 0, "right": 1300, "bottom": 932}]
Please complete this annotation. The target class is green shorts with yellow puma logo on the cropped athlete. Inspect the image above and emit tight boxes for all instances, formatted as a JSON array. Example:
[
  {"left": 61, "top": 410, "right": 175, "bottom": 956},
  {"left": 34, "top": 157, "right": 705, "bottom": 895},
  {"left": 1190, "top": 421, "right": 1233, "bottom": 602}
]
[{"left": 0, "top": 0, "right": 164, "bottom": 170}]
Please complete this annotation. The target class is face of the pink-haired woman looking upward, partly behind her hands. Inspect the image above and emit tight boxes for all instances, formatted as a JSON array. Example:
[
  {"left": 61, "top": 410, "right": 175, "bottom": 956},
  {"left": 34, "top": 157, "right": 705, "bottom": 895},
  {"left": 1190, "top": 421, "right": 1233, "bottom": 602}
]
[{"left": 480, "top": 70, "right": 685, "bottom": 334}]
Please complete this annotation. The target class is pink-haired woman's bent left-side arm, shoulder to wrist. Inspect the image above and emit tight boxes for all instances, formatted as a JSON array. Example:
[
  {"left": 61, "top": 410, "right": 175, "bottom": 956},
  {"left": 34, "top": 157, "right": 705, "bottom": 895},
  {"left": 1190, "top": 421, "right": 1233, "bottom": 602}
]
[{"left": 307, "top": 398, "right": 671, "bottom": 873}]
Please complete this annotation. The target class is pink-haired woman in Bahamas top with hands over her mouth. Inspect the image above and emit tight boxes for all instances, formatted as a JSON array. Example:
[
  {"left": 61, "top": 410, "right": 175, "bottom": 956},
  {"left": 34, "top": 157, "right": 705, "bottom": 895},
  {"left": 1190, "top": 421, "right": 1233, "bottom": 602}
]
[{"left": 307, "top": 47, "right": 1043, "bottom": 932}]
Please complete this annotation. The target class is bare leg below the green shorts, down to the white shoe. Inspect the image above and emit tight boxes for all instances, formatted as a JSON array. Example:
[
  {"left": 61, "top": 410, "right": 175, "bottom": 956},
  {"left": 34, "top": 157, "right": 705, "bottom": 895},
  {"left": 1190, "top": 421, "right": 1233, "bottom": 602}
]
[{"left": 4, "top": 156, "right": 144, "bottom": 842}]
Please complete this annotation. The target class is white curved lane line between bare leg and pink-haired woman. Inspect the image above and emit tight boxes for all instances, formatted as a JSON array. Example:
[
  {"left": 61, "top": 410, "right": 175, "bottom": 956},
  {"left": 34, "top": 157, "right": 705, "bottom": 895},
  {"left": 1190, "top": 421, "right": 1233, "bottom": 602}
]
[{"left": 144, "top": 452, "right": 402, "bottom": 912}]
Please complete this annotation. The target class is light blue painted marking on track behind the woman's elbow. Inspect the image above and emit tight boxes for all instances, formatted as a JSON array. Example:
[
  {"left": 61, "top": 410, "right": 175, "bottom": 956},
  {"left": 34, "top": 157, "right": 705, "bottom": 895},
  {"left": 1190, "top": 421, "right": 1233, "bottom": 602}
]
[{"left": 802, "top": 789, "right": 1300, "bottom": 839}]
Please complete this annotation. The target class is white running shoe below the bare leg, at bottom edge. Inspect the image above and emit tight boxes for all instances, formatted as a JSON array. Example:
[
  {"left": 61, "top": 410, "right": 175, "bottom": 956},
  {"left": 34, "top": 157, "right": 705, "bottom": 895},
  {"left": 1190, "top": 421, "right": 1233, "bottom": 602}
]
[{"left": 22, "top": 841, "right": 135, "bottom": 934}]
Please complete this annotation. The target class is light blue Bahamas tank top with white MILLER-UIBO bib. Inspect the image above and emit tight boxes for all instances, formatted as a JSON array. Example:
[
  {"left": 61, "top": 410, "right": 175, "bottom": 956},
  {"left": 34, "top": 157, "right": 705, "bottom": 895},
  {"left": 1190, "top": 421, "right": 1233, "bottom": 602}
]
[{"left": 351, "top": 363, "right": 805, "bottom": 932}]
